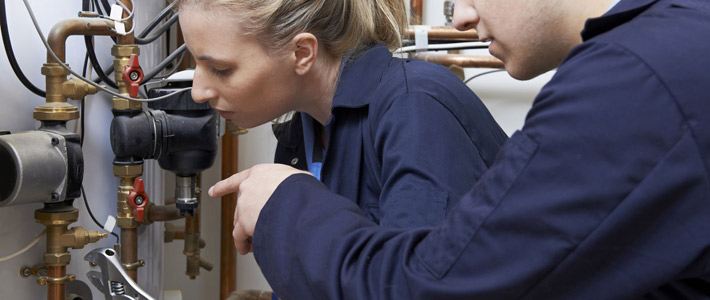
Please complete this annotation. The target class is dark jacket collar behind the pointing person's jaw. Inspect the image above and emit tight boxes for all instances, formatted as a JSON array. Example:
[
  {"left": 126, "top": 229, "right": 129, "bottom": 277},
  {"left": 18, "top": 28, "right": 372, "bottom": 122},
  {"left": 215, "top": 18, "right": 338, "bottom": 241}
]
[{"left": 582, "top": 0, "right": 660, "bottom": 41}]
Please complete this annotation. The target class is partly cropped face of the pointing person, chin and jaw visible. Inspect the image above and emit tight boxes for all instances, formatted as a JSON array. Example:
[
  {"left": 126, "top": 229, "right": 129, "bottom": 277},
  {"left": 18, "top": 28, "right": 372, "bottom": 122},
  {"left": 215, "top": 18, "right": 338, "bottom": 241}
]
[{"left": 454, "top": 0, "right": 613, "bottom": 80}]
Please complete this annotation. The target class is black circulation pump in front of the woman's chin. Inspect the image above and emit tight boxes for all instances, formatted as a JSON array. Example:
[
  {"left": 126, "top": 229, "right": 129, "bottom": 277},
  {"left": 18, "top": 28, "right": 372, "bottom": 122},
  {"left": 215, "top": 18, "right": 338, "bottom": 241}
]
[{"left": 111, "top": 86, "right": 218, "bottom": 215}]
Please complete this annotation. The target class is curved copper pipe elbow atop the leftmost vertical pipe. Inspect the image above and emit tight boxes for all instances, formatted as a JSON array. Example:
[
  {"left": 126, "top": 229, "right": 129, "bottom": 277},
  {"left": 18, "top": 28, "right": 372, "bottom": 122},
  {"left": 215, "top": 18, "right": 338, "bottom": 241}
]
[{"left": 47, "top": 18, "right": 116, "bottom": 62}]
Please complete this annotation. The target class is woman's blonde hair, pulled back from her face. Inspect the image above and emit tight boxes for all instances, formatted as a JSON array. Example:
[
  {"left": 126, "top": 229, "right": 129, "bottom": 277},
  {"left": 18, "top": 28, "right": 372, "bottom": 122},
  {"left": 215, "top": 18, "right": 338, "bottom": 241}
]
[{"left": 177, "top": 0, "right": 407, "bottom": 57}]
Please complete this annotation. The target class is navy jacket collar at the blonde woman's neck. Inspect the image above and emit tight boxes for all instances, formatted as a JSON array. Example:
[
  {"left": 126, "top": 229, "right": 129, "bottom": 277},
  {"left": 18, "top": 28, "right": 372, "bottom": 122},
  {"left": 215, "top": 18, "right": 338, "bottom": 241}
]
[{"left": 331, "top": 44, "right": 392, "bottom": 109}]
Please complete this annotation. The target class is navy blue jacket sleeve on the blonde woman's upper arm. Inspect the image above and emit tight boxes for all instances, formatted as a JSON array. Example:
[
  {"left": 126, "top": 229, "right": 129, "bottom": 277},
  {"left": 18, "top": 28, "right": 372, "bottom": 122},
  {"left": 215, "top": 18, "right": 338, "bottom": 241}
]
[{"left": 374, "top": 92, "right": 498, "bottom": 227}]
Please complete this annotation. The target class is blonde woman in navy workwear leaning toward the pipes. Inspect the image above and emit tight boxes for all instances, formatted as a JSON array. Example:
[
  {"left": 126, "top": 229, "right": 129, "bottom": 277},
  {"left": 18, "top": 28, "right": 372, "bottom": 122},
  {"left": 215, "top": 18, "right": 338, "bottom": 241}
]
[{"left": 179, "top": 0, "right": 507, "bottom": 227}]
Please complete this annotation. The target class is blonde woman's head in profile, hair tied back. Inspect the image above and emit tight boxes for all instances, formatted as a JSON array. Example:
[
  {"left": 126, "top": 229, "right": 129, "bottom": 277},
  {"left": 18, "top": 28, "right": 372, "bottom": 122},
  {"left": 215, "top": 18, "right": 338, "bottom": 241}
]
[{"left": 177, "top": 0, "right": 406, "bottom": 127}]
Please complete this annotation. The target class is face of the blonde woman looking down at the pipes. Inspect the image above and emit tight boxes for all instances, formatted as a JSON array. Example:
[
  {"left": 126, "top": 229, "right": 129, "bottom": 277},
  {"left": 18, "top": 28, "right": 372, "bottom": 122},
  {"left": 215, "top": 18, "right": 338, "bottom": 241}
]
[{"left": 180, "top": 5, "right": 299, "bottom": 128}]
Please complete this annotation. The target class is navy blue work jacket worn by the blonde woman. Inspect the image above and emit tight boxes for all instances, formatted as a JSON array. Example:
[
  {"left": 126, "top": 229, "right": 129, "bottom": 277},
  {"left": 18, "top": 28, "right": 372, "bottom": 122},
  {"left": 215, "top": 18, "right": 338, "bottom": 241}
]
[{"left": 275, "top": 44, "right": 507, "bottom": 227}]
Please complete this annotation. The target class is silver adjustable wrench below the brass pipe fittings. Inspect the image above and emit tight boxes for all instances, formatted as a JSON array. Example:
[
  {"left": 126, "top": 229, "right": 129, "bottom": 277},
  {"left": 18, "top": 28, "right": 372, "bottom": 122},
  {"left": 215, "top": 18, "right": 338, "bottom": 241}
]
[{"left": 84, "top": 248, "right": 155, "bottom": 300}]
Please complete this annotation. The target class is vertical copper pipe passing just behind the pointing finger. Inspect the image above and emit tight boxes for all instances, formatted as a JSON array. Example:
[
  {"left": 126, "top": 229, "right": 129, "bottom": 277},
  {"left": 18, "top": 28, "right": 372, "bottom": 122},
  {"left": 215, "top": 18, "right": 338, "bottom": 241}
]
[{"left": 219, "top": 121, "right": 239, "bottom": 300}]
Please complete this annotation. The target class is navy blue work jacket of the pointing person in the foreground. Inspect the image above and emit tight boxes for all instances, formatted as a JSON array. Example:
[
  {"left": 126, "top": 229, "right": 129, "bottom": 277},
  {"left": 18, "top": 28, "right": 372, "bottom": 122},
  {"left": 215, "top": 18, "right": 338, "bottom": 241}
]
[{"left": 253, "top": 0, "right": 710, "bottom": 300}]
